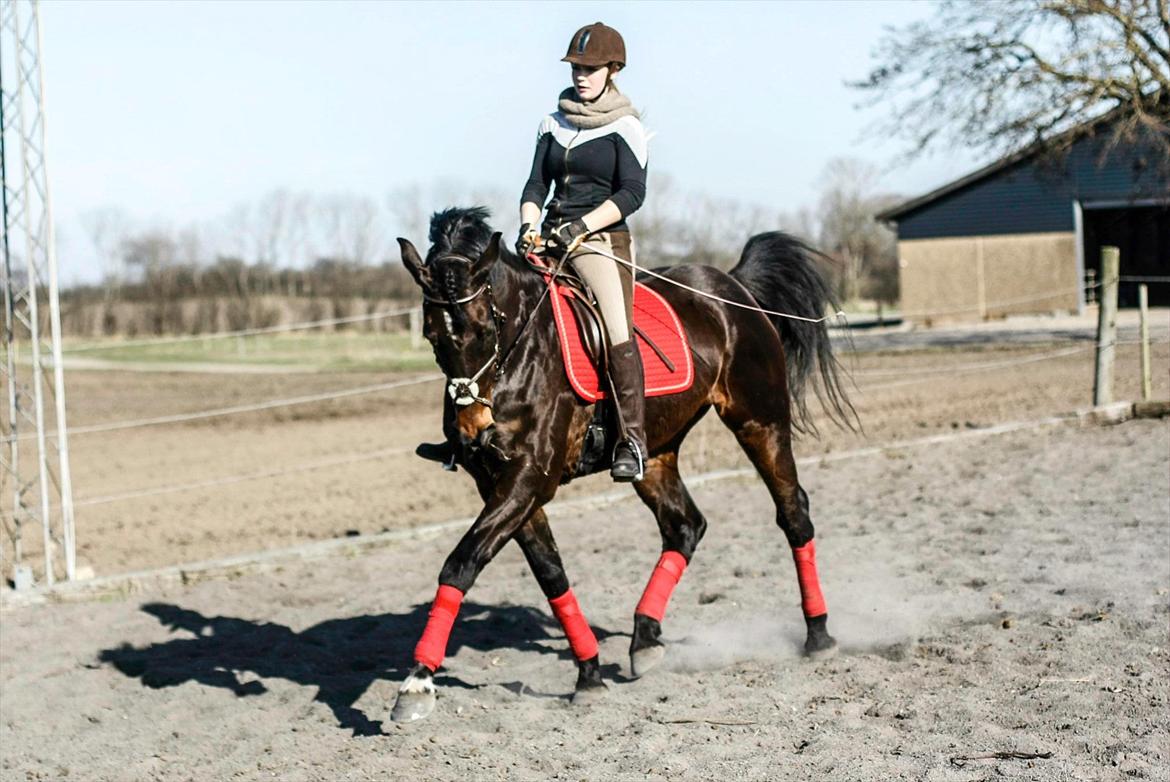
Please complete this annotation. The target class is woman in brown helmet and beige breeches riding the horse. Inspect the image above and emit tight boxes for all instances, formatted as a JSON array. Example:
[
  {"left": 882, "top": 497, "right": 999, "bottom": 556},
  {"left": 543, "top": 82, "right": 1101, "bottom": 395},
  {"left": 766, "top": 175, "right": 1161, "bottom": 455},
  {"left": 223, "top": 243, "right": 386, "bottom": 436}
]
[{"left": 516, "top": 22, "right": 647, "bottom": 481}]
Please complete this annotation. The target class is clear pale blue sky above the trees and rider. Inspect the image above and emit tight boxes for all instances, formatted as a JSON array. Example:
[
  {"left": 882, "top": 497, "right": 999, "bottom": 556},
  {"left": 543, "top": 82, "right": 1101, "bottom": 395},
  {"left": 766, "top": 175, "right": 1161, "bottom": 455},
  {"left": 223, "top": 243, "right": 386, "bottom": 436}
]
[{"left": 42, "top": 0, "right": 977, "bottom": 281}]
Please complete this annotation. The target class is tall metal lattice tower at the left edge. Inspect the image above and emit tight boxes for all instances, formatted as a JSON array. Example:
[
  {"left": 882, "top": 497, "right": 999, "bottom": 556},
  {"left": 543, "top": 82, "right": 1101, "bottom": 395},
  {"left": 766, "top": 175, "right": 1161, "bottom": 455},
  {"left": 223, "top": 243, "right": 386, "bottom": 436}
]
[{"left": 0, "top": 0, "right": 76, "bottom": 588}]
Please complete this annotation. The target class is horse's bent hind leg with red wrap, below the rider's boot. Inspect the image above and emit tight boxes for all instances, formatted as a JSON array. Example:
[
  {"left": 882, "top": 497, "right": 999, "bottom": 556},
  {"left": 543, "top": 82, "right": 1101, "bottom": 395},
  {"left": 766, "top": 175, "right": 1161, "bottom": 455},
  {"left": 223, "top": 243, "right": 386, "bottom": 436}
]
[{"left": 629, "top": 452, "right": 707, "bottom": 677}]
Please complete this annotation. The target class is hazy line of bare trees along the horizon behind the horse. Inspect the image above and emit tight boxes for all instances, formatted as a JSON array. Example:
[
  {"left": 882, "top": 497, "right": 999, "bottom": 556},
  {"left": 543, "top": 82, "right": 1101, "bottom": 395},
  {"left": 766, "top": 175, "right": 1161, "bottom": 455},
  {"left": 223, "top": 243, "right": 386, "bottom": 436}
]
[{"left": 62, "top": 160, "right": 897, "bottom": 336}]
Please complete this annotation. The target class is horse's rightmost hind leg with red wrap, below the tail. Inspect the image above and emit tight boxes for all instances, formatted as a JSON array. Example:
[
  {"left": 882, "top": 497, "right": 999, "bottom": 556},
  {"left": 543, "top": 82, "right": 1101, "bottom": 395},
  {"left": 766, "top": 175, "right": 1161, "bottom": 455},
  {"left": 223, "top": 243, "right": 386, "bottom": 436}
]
[{"left": 718, "top": 393, "right": 837, "bottom": 656}]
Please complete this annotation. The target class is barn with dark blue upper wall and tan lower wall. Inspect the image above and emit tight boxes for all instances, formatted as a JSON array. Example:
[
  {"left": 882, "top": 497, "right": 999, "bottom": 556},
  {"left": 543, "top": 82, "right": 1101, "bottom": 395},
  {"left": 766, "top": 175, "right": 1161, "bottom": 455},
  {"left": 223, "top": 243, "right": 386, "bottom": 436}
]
[{"left": 878, "top": 120, "right": 1170, "bottom": 322}]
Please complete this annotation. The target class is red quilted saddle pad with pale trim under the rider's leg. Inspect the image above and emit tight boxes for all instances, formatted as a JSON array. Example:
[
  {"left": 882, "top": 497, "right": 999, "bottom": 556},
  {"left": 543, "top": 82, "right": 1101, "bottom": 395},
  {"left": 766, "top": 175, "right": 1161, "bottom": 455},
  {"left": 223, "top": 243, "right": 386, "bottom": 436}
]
[{"left": 550, "top": 282, "right": 695, "bottom": 402}]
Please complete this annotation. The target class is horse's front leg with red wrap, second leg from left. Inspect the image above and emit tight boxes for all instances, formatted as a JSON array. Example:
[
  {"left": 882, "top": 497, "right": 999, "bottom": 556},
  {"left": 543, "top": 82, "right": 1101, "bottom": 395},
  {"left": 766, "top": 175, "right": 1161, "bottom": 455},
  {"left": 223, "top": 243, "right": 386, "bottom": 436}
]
[{"left": 516, "top": 510, "right": 606, "bottom": 704}]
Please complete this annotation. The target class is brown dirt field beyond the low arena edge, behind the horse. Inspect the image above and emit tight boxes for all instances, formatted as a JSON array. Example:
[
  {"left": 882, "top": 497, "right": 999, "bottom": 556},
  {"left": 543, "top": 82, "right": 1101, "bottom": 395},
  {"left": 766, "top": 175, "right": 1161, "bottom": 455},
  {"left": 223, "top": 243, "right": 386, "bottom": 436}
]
[{"left": 4, "top": 318, "right": 1170, "bottom": 577}]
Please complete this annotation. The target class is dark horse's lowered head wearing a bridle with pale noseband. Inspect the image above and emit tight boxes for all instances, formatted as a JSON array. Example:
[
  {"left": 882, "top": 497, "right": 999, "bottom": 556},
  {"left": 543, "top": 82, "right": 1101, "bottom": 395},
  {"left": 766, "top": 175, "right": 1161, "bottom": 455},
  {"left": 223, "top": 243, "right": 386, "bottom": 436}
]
[{"left": 398, "top": 208, "right": 501, "bottom": 438}]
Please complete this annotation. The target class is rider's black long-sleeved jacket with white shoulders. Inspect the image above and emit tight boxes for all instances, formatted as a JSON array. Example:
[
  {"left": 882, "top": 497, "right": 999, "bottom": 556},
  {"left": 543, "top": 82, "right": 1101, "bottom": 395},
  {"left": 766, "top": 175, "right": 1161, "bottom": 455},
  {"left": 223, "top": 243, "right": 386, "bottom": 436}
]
[{"left": 521, "top": 111, "right": 647, "bottom": 231}]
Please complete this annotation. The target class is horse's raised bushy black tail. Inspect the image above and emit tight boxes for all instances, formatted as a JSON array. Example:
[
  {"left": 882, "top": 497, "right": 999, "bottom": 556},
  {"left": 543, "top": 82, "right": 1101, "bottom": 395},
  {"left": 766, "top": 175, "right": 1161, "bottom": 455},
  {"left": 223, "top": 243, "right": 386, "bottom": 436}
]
[{"left": 731, "top": 231, "right": 858, "bottom": 433}]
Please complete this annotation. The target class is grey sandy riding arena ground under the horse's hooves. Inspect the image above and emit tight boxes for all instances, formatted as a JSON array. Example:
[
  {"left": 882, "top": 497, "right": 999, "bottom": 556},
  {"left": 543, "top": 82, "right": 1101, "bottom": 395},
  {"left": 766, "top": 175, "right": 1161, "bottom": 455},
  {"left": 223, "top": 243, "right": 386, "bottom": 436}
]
[{"left": 0, "top": 412, "right": 1170, "bottom": 782}]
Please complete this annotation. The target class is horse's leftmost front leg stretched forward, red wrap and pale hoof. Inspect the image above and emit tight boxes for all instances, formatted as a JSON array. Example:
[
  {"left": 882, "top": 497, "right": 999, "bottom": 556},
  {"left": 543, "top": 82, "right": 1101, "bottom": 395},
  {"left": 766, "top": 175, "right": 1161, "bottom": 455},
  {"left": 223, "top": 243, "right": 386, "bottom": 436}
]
[{"left": 391, "top": 461, "right": 549, "bottom": 722}]
